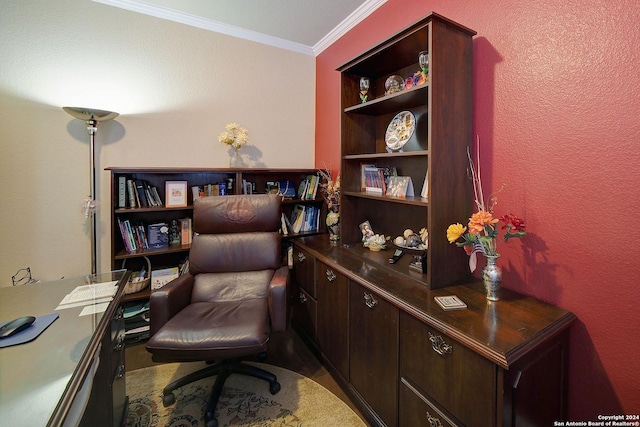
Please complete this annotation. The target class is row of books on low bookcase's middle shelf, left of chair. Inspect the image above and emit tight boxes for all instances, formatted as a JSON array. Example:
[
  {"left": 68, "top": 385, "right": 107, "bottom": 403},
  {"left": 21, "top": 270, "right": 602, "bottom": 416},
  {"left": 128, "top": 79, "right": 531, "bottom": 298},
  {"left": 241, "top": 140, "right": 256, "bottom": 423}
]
[{"left": 117, "top": 218, "right": 193, "bottom": 253}]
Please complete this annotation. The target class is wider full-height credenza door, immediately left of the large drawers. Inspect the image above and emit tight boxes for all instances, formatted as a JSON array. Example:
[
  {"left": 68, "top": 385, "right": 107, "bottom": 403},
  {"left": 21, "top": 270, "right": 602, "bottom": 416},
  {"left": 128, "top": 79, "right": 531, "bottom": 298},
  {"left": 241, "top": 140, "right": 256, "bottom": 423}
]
[{"left": 349, "top": 282, "right": 398, "bottom": 426}]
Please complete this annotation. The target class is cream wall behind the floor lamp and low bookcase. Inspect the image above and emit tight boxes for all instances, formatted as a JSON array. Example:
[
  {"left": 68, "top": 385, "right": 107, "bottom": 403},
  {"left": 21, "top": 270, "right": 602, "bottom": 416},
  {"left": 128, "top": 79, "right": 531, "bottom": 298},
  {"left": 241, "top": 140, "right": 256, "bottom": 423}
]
[{"left": 0, "top": 0, "right": 315, "bottom": 286}]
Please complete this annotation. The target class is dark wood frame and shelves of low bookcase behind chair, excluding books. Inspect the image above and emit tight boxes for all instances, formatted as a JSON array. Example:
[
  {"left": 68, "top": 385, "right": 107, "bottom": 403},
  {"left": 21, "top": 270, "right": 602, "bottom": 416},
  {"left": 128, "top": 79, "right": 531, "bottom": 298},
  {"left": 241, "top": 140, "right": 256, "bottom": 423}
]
[{"left": 107, "top": 167, "right": 325, "bottom": 301}]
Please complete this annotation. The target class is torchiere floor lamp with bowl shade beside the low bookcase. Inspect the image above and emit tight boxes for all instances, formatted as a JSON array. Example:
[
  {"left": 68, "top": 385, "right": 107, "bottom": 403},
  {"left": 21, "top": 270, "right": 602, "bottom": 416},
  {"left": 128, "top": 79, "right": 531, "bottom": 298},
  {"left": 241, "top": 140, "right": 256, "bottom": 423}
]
[{"left": 62, "top": 107, "right": 118, "bottom": 274}]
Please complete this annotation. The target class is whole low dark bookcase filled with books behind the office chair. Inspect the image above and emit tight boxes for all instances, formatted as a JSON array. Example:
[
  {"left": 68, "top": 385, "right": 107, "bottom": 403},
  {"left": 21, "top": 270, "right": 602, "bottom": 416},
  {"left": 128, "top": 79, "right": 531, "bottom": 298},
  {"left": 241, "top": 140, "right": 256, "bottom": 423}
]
[{"left": 106, "top": 167, "right": 326, "bottom": 300}]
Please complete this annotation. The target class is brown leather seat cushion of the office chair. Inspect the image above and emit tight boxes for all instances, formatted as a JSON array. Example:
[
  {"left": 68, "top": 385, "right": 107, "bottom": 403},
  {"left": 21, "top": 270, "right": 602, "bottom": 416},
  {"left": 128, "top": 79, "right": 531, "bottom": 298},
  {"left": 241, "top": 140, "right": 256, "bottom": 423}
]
[{"left": 147, "top": 298, "right": 270, "bottom": 362}]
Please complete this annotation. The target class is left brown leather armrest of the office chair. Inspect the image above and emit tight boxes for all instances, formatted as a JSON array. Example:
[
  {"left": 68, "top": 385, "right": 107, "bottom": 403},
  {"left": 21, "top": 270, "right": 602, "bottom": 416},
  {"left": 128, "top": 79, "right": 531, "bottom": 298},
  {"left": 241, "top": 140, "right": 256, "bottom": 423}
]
[{"left": 149, "top": 273, "right": 193, "bottom": 336}]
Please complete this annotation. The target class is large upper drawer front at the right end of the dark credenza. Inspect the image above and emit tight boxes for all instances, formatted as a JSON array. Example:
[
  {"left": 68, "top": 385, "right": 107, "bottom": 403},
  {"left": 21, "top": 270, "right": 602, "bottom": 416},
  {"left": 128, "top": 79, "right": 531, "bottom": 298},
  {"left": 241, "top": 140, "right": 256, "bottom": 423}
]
[{"left": 400, "top": 313, "right": 498, "bottom": 425}]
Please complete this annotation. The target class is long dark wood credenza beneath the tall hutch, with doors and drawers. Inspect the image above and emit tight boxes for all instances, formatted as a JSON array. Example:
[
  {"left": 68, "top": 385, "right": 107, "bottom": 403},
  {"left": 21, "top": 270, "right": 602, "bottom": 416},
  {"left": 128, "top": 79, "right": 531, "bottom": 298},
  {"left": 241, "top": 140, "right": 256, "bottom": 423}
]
[{"left": 294, "top": 235, "right": 575, "bottom": 427}]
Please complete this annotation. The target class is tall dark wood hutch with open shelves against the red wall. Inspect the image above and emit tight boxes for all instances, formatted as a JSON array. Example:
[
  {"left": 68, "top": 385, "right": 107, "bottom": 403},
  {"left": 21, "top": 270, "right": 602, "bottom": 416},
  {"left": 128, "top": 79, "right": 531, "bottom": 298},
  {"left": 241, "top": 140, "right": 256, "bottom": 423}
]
[{"left": 338, "top": 13, "right": 476, "bottom": 289}]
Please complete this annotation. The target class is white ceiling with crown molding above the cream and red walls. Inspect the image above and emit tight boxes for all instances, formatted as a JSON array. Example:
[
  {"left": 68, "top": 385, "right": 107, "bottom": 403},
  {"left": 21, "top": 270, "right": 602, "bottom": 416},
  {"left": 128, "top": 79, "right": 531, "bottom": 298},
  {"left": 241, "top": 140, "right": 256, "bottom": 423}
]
[{"left": 93, "top": 0, "right": 387, "bottom": 55}]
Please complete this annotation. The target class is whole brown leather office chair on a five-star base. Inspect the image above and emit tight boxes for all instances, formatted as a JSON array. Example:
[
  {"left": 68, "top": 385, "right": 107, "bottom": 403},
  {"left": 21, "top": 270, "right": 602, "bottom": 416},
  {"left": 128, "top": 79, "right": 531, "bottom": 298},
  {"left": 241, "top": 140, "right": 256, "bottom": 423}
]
[{"left": 147, "top": 195, "right": 289, "bottom": 427}]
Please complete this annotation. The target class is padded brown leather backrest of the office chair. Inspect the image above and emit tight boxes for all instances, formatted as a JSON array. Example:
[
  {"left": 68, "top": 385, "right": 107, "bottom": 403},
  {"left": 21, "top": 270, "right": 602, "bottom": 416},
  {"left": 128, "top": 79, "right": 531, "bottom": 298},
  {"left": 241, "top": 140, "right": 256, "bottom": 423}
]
[{"left": 189, "top": 194, "right": 282, "bottom": 276}]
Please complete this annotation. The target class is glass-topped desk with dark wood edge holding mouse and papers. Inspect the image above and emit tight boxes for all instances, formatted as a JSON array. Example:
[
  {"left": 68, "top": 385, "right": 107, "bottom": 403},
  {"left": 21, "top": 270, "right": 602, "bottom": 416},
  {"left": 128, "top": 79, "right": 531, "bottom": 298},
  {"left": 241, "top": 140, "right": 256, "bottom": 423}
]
[{"left": 0, "top": 270, "right": 129, "bottom": 426}]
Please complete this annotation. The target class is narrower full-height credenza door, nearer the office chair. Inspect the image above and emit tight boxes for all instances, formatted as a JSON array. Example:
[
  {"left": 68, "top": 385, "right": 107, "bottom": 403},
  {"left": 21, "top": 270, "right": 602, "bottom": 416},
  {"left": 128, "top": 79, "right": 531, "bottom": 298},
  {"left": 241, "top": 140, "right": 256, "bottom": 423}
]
[{"left": 318, "top": 262, "right": 349, "bottom": 378}]
